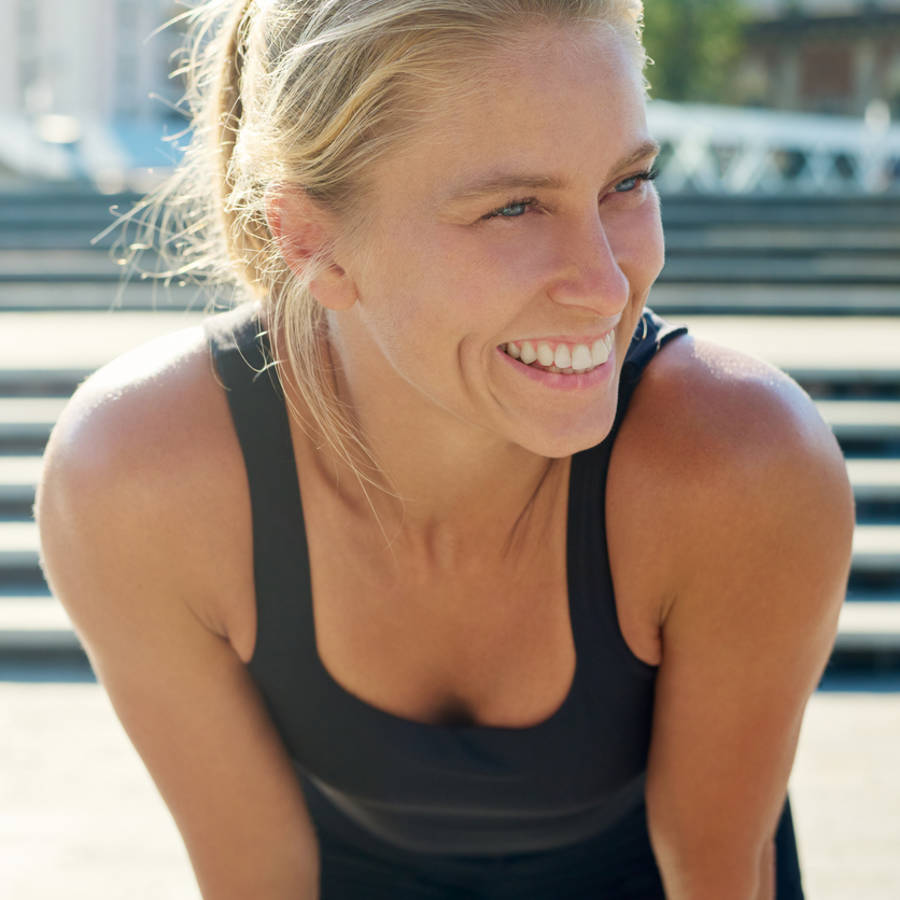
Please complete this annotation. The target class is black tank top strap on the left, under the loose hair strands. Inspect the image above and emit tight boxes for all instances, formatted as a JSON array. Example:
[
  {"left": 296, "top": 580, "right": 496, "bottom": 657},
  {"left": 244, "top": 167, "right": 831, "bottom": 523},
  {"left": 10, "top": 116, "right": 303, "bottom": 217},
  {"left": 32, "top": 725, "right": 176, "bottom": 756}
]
[{"left": 204, "top": 304, "right": 315, "bottom": 671}]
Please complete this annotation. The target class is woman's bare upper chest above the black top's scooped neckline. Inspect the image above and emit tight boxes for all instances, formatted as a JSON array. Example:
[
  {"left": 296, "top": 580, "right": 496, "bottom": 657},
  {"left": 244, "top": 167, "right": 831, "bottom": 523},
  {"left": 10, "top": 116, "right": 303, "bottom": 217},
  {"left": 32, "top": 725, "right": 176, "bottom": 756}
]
[{"left": 307, "top": 500, "right": 576, "bottom": 727}]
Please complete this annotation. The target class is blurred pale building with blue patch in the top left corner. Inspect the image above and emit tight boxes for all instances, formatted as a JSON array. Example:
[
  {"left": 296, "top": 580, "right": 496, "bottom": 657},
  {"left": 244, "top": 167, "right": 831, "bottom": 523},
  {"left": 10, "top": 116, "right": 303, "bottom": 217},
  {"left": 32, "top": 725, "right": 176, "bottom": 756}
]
[{"left": 0, "top": 0, "right": 185, "bottom": 188}]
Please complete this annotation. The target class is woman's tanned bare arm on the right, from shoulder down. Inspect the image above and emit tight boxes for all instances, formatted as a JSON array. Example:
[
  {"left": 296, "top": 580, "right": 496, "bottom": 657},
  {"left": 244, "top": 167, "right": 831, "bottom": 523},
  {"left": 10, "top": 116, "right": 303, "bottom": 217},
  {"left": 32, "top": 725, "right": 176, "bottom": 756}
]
[{"left": 616, "top": 340, "right": 853, "bottom": 898}]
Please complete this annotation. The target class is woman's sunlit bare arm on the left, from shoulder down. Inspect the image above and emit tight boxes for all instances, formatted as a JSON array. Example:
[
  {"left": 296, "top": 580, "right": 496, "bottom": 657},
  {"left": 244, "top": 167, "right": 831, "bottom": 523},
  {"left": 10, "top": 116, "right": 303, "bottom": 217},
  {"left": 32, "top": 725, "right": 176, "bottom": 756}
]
[{"left": 37, "top": 342, "right": 317, "bottom": 900}]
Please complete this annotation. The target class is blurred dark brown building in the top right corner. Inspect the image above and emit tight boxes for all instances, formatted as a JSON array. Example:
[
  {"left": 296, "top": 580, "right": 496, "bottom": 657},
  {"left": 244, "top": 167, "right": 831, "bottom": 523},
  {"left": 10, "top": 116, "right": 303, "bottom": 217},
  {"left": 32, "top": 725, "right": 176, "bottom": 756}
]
[{"left": 738, "top": 0, "right": 900, "bottom": 119}]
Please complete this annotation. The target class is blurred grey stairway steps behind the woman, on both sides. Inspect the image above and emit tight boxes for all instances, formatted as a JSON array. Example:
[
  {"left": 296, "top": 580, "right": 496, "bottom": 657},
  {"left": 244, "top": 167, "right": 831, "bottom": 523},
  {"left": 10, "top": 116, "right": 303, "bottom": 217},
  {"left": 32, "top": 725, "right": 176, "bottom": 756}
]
[{"left": 0, "top": 191, "right": 900, "bottom": 670}]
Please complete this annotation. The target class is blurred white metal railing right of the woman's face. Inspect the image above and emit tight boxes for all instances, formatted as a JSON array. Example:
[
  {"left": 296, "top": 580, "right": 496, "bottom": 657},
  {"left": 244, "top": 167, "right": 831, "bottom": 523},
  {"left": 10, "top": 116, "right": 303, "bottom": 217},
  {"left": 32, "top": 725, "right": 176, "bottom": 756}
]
[{"left": 649, "top": 100, "right": 900, "bottom": 195}]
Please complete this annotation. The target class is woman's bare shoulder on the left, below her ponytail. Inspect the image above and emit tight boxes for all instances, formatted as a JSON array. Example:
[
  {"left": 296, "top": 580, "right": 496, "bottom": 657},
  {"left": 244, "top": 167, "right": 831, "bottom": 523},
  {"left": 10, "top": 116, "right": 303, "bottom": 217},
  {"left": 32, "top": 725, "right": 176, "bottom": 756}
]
[{"left": 36, "top": 326, "right": 249, "bottom": 652}]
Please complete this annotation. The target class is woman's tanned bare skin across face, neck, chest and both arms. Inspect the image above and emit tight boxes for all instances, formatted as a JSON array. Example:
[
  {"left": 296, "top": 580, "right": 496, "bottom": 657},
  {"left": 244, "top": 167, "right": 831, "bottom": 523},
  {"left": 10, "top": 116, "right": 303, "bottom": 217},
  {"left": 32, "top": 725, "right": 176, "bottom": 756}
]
[{"left": 38, "top": 14, "right": 853, "bottom": 900}]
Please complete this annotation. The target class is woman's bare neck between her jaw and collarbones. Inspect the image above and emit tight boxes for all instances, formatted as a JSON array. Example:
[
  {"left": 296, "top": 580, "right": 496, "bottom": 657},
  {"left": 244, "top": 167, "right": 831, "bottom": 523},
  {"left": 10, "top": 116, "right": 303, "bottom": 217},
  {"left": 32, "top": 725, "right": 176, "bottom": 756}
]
[{"left": 286, "top": 338, "right": 568, "bottom": 568}]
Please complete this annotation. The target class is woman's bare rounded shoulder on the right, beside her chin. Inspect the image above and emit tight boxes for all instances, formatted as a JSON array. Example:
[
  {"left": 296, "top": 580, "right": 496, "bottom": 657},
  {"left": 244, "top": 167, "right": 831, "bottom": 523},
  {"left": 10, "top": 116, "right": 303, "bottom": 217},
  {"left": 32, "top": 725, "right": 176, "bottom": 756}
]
[{"left": 609, "top": 326, "right": 853, "bottom": 624}]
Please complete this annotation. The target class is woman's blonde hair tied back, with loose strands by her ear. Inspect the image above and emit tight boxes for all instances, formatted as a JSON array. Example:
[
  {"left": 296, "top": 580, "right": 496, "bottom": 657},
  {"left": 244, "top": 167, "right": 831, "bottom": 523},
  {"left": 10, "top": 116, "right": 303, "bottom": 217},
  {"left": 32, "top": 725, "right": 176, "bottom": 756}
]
[{"left": 141, "top": 0, "right": 646, "bottom": 481}]
